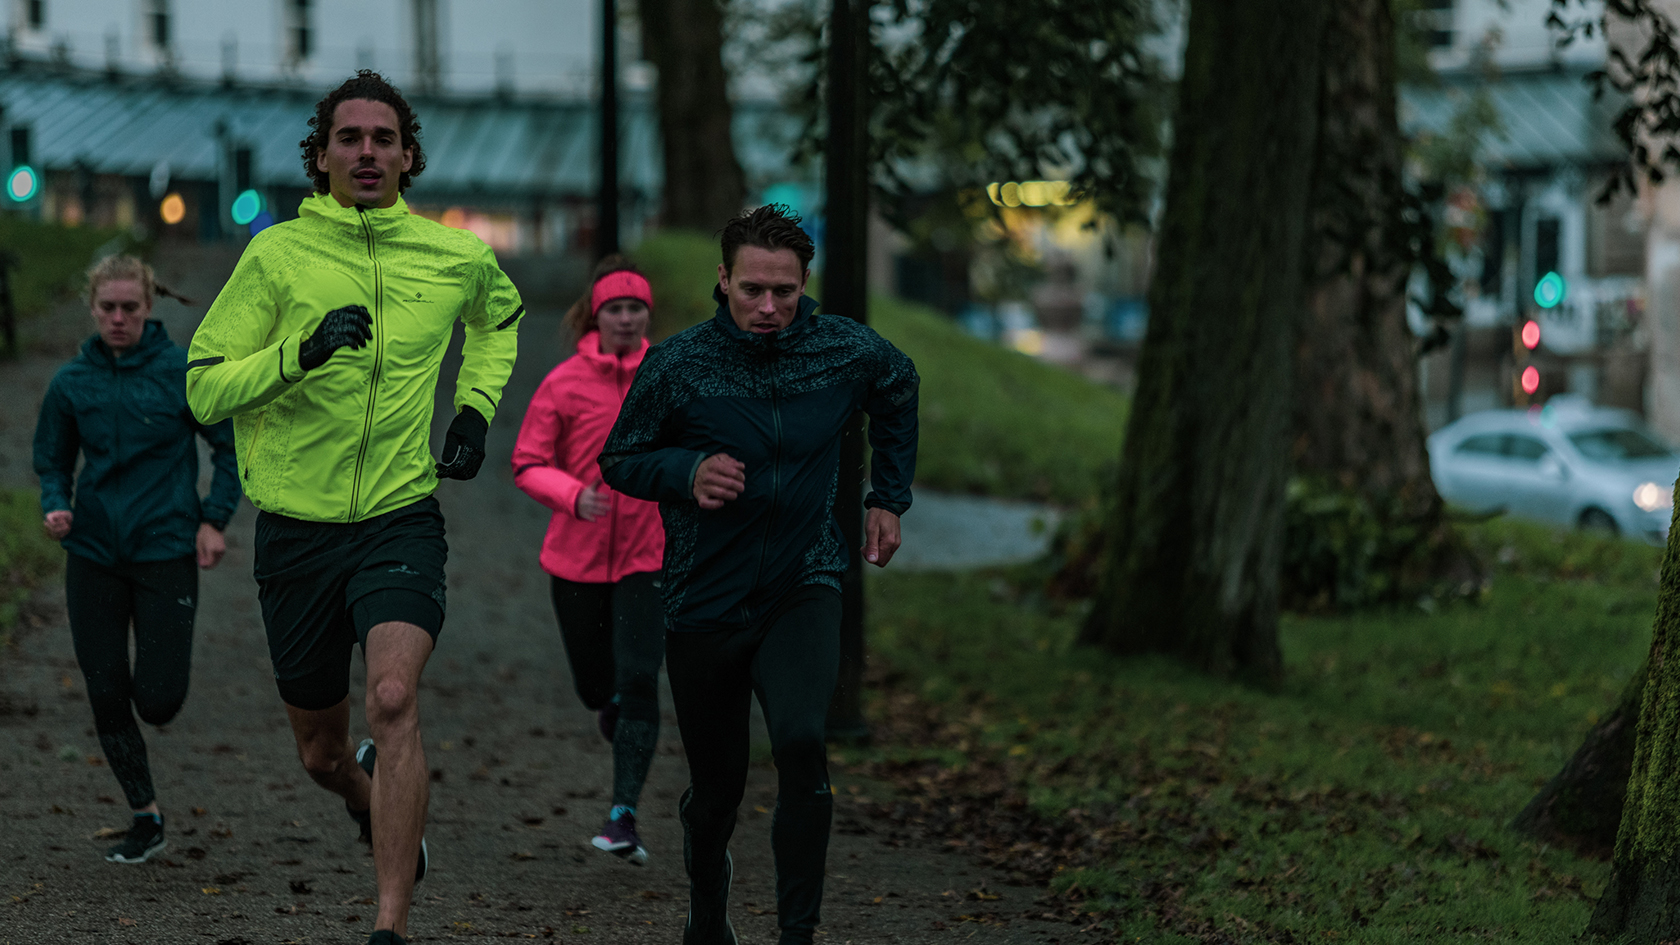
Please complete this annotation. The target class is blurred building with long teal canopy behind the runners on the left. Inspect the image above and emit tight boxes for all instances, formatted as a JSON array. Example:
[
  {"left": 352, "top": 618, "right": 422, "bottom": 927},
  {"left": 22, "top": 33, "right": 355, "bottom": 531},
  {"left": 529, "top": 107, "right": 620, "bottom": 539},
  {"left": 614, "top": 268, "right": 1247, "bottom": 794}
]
[{"left": 0, "top": 0, "right": 800, "bottom": 300}]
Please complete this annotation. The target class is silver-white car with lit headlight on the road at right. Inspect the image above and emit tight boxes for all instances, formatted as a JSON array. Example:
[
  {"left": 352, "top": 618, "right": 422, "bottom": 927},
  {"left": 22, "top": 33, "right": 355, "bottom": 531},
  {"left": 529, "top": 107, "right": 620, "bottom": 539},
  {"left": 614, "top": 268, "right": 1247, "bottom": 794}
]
[{"left": 1430, "top": 397, "right": 1680, "bottom": 545}]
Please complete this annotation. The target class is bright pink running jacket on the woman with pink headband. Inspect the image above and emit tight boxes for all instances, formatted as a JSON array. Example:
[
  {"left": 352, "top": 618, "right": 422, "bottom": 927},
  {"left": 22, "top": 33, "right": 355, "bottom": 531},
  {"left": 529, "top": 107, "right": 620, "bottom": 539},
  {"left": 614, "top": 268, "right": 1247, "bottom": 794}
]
[{"left": 514, "top": 331, "right": 665, "bottom": 583}]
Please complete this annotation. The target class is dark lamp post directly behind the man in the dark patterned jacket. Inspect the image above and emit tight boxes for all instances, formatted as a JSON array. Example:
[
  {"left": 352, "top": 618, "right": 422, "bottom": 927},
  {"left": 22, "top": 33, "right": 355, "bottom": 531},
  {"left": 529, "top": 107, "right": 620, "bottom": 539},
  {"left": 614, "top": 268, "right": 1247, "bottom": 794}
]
[{"left": 823, "top": 0, "right": 869, "bottom": 742}]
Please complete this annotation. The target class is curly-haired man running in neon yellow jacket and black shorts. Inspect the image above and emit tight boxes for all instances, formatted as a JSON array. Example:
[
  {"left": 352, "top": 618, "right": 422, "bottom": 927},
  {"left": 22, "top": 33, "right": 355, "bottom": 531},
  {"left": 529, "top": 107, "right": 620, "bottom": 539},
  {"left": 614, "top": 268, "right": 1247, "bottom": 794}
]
[{"left": 186, "top": 71, "right": 524, "bottom": 943}]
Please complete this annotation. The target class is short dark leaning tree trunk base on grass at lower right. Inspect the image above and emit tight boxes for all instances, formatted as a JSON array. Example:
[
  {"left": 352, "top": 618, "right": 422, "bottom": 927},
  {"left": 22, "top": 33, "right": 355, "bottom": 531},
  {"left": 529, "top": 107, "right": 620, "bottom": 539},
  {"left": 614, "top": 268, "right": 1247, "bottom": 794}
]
[{"left": 1510, "top": 666, "right": 1646, "bottom": 859}]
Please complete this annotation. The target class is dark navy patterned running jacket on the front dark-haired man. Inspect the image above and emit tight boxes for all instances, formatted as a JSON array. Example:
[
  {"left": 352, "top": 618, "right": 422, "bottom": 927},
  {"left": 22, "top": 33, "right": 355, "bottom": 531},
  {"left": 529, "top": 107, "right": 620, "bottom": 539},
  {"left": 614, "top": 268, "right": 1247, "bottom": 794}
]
[{"left": 600, "top": 291, "right": 921, "bottom": 631}]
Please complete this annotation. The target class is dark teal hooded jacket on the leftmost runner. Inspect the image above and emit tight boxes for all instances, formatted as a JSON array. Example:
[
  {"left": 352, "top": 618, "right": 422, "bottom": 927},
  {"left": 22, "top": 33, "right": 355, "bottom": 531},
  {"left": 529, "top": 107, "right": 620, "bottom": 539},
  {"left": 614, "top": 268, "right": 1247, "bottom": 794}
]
[{"left": 35, "top": 321, "right": 240, "bottom": 565}]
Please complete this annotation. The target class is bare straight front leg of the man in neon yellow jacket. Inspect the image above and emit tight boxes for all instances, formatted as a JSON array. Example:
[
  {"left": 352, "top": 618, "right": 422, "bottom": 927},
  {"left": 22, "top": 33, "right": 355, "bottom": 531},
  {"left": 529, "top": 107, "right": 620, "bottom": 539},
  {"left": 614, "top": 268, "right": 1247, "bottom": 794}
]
[{"left": 362, "top": 620, "right": 432, "bottom": 935}]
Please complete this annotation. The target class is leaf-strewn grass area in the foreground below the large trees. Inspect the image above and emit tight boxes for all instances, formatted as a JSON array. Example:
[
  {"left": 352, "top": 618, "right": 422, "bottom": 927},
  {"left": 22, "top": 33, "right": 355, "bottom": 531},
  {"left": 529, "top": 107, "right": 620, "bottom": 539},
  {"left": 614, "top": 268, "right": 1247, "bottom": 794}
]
[{"left": 850, "top": 511, "right": 1662, "bottom": 943}]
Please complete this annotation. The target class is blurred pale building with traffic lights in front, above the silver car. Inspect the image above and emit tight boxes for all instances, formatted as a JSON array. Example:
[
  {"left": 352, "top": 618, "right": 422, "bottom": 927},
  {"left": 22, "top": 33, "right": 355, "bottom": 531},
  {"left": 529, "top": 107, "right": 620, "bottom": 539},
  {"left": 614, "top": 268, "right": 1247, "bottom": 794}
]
[{"left": 1401, "top": 0, "right": 1639, "bottom": 432}]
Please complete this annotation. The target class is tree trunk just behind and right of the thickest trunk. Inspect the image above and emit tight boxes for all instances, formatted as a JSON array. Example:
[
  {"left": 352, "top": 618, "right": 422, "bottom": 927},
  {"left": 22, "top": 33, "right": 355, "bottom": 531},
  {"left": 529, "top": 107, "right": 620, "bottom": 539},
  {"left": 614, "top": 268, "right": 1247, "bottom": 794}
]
[{"left": 1292, "top": 0, "right": 1441, "bottom": 518}]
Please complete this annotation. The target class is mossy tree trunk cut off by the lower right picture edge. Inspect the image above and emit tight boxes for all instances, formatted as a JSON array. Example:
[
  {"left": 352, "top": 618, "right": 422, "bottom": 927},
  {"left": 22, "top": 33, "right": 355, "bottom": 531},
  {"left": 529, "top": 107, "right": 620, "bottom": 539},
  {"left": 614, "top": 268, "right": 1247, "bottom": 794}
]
[{"left": 1566, "top": 528, "right": 1680, "bottom": 942}]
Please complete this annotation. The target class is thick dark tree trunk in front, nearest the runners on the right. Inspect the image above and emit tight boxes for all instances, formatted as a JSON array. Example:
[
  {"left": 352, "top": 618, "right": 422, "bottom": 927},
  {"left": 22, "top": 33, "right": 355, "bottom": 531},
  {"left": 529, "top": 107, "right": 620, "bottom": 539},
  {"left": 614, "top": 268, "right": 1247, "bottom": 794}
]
[{"left": 1082, "top": 0, "right": 1329, "bottom": 678}]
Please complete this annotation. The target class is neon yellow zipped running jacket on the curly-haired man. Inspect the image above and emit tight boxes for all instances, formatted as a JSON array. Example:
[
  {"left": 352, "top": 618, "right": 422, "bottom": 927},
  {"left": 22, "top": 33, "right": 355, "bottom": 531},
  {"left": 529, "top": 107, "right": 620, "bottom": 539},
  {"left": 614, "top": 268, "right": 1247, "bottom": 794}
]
[{"left": 186, "top": 193, "right": 524, "bottom": 521}]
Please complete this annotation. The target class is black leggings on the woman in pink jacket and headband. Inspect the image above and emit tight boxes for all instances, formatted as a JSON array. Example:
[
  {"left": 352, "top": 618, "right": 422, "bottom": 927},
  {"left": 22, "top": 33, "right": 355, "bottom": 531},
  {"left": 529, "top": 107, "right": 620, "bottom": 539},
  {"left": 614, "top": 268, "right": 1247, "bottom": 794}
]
[{"left": 549, "top": 572, "right": 665, "bottom": 807}]
